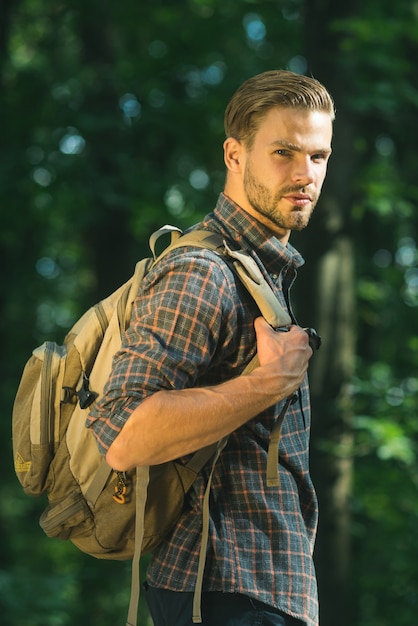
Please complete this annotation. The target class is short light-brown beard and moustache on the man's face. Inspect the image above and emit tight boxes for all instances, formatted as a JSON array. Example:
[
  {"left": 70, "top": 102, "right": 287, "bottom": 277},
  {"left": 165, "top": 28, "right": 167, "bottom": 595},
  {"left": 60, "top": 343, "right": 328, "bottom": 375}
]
[{"left": 244, "top": 164, "right": 317, "bottom": 230}]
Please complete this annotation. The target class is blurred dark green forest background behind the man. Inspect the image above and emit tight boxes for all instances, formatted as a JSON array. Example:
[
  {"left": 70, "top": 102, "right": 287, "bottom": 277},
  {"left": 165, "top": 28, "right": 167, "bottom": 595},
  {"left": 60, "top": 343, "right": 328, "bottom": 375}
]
[{"left": 0, "top": 0, "right": 418, "bottom": 626}]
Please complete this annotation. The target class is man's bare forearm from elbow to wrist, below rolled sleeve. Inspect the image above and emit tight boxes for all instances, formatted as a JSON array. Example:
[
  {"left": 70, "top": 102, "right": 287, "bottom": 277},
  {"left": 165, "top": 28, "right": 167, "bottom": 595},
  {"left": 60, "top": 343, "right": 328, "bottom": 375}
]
[{"left": 107, "top": 370, "right": 284, "bottom": 471}]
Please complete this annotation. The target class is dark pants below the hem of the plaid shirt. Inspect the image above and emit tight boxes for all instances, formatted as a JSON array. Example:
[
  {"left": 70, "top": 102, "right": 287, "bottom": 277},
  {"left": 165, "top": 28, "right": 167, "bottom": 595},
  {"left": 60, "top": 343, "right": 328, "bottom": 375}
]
[{"left": 145, "top": 587, "right": 304, "bottom": 626}]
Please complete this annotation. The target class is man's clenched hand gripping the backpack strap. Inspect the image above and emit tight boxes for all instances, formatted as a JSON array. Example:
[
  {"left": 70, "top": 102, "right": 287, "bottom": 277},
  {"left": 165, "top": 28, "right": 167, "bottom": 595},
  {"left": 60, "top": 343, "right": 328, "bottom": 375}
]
[{"left": 254, "top": 317, "right": 312, "bottom": 396}]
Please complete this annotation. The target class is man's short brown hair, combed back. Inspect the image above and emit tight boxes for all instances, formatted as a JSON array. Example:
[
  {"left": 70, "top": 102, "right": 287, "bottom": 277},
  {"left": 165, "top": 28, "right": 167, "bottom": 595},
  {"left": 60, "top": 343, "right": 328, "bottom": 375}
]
[{"left": 224, "top": 70, "right": 335, "bottom": 148}]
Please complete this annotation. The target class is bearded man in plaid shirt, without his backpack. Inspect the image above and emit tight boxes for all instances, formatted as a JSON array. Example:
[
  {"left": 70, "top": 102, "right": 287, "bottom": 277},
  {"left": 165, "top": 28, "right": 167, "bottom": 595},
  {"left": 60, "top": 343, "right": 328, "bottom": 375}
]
[{"left": 88, "top": 71, "right": 334, "bottom": 626}]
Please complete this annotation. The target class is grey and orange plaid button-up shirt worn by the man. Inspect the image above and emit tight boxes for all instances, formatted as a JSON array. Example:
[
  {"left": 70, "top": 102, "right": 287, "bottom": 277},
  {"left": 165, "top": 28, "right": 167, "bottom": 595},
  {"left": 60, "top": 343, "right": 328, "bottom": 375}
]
[{"left": 89, "top": 194, "right": 318, "bottom": 626}]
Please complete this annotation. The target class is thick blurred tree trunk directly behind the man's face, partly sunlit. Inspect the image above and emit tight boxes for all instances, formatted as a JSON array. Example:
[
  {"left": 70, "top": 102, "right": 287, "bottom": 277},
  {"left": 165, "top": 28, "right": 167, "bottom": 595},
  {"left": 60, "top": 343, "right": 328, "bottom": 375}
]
[{"left": 296, "top": 0, "right": 356, "bottom": 626}]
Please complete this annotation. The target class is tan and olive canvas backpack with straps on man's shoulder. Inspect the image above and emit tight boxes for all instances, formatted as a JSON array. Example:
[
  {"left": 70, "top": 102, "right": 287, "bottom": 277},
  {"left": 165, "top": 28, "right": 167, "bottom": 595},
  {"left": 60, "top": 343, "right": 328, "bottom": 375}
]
[{"left": 12, "top": 226, "right": 291, "bottom": 626}]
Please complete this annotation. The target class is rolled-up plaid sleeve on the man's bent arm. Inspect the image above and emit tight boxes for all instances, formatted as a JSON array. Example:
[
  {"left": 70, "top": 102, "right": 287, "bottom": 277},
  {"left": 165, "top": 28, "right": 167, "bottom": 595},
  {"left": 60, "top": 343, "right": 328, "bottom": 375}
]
[{"left": 87, "top": 250, "right": 237, "bottom": 454}]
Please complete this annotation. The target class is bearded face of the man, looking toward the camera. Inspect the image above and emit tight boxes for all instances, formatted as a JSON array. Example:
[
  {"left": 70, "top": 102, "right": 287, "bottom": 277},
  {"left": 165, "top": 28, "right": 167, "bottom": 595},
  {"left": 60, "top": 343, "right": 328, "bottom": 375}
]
[{"left": 241, "top": 108, "right": 332, "bottom": 239}]
